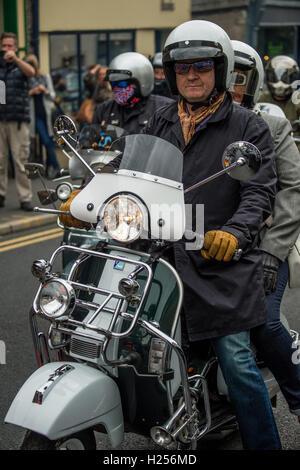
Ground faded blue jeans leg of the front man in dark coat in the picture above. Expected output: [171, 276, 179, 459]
[212, 331, 281, 450]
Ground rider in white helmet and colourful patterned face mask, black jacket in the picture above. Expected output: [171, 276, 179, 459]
[93, 52, 175, 134]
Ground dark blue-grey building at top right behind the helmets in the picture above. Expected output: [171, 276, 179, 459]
[192, 0, 300, 63]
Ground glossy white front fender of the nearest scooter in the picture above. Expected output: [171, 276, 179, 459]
[5, 362, 124, 447]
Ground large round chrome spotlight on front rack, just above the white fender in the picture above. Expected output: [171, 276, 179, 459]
[39, 279, 75, 319]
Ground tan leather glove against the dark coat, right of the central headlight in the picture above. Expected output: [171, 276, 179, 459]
[201, 230, 239, 262]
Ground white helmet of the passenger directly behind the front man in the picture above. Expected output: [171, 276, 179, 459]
[231, 41, 265, 108]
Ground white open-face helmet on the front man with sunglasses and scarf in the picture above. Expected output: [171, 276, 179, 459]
[163, 20, 234, 95]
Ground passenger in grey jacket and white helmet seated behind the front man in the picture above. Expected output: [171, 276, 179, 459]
[231, 41, 300, 419]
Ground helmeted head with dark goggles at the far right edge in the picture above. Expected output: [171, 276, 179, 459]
[266, 55, 299, 100]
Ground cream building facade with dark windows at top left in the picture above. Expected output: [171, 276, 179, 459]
[0, 0, 191, 113]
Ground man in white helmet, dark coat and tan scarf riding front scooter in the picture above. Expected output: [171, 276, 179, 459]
[144, 20, 281, 450]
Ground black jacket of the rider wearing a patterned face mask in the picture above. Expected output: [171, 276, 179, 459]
[93, 95, 173, 134]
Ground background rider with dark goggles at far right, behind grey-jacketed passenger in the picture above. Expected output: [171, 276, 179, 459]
[258, 55, 300, 150]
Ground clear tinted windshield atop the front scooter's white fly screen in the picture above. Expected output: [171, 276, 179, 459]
[111, 134, 183, 182]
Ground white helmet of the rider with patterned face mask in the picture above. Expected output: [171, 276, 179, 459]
[106, 52, 154, 97]
